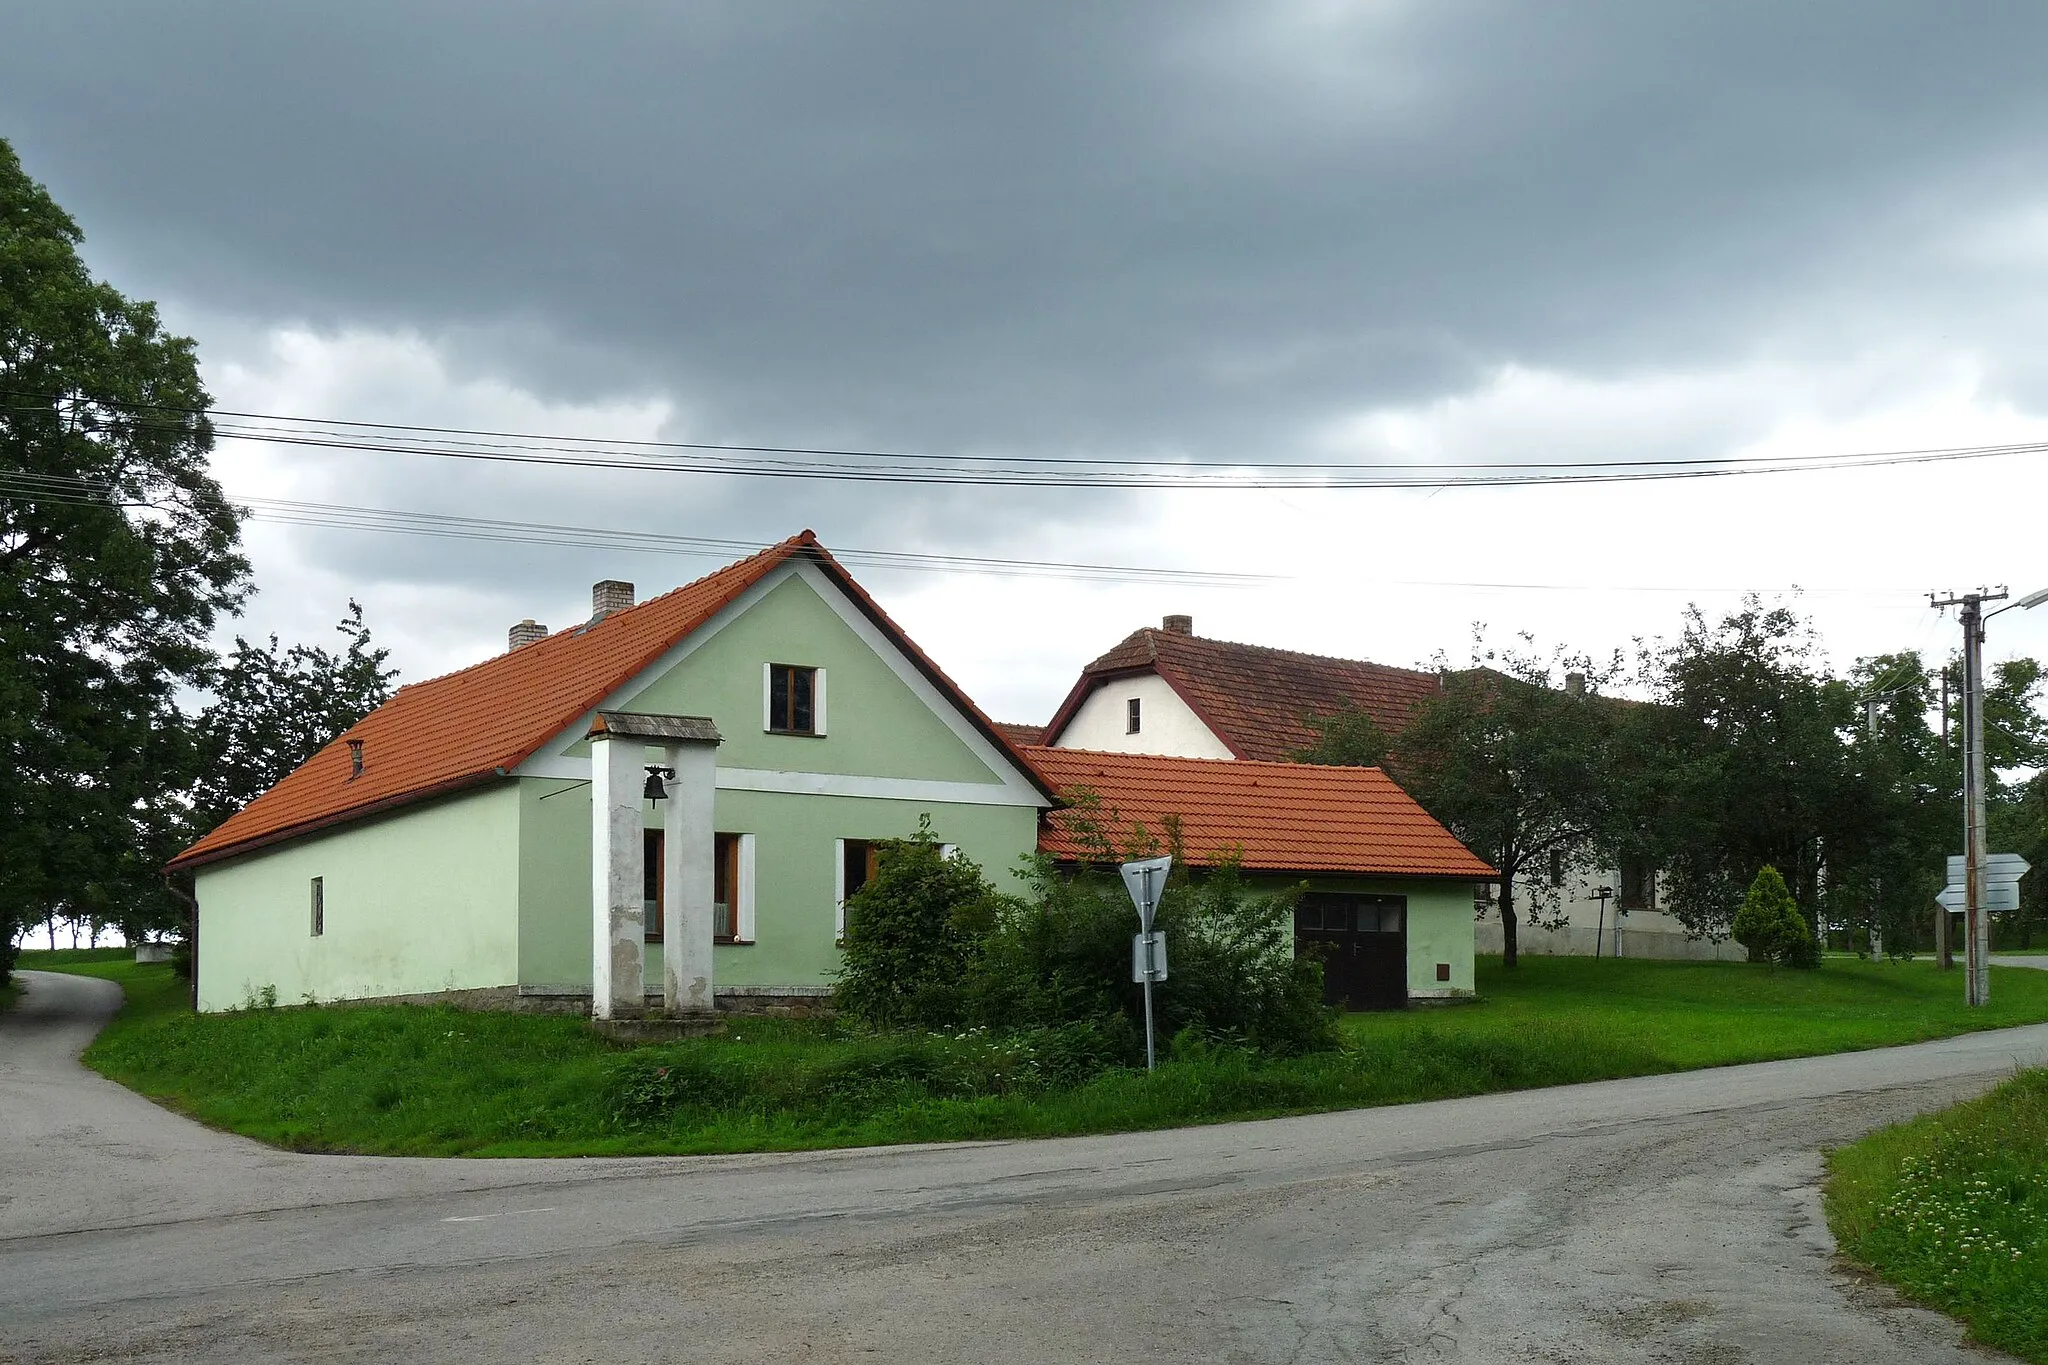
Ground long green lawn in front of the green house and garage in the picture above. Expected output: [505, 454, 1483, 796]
[23, 956, 2048, 1156]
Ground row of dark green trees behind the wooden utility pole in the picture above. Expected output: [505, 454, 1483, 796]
[1298, 596, 2048, 964]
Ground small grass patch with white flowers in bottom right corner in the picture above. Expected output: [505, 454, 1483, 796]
[1827, 1070, 2048, 1363]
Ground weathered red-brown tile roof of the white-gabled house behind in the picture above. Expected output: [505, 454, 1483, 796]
[1047, 628, 1440, 761]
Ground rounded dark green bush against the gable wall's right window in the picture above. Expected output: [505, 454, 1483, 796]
[836, 817, 999, 1029]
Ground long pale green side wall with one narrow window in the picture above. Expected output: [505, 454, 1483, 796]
[197, 782, 520, 1009]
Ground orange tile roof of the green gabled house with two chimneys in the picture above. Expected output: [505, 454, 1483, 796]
[170, 530, 1051, 868]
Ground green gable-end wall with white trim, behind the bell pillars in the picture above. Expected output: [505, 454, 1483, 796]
[518, 571, 1042, 990]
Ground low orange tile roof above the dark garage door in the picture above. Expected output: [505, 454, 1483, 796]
[1024, 749, 1495, 880]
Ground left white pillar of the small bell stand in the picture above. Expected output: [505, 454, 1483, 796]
[590, 720, 647, 1019]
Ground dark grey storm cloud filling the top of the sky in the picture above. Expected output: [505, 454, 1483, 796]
[16, 0, 2048, 454]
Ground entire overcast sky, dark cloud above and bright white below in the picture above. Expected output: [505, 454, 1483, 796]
[0, 0, 2048, 720]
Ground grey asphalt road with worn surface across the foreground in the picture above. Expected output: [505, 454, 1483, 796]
[0, 974, 2048, 1365]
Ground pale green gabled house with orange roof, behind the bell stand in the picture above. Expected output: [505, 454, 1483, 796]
[172, 532, 1055, 1017]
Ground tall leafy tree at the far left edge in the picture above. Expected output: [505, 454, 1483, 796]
[0, 141, 248, 982]
